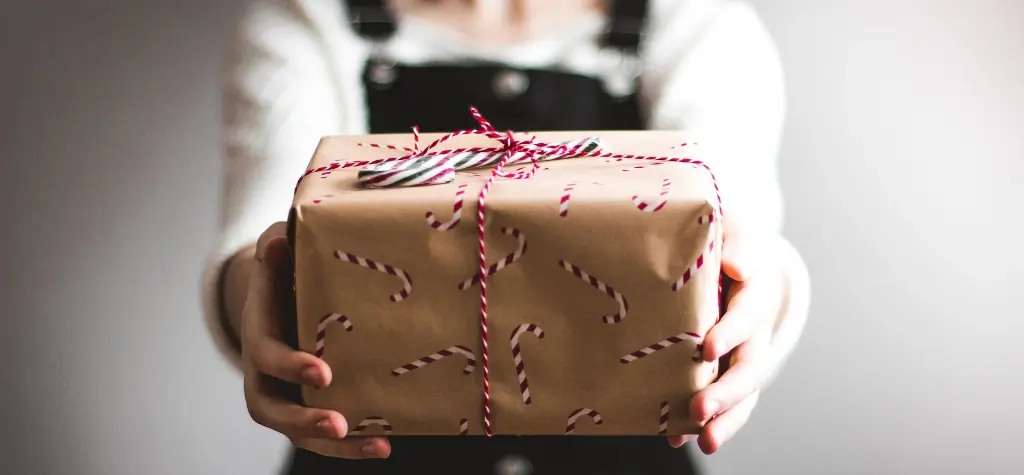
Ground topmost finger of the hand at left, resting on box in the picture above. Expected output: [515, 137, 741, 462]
[243, 246, 332, 387]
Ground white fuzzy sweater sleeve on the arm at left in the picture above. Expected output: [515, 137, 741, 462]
[202, 0, 341, 365]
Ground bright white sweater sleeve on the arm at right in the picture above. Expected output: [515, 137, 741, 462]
[641, 0, 810, 384]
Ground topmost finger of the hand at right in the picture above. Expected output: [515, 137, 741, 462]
[702, 272, 782, 361]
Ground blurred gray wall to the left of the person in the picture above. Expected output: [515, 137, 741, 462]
[0, 0, 284, 475]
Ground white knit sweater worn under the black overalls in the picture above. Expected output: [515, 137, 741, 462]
[203, 0, 809, 378]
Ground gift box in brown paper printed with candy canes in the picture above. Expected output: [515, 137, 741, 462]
[289, 114, 722, 435]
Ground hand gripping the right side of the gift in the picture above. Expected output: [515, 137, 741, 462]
[669, 220, 785, 455]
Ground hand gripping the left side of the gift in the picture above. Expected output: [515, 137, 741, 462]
[241, 223, 391, 459]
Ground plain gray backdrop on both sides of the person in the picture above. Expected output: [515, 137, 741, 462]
[0, 0, 1024, 475]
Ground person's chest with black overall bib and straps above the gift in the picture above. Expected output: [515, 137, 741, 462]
[356, 0, 646, 133]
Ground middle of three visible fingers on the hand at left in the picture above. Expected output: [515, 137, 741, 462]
[244, 366, 348, 439]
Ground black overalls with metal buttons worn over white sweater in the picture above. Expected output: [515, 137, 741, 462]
[288, 0, 695, 475]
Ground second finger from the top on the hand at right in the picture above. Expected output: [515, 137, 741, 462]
[690, 337, 768, 424]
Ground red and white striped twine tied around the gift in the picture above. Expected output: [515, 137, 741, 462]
[295, 107, 724, 436]
